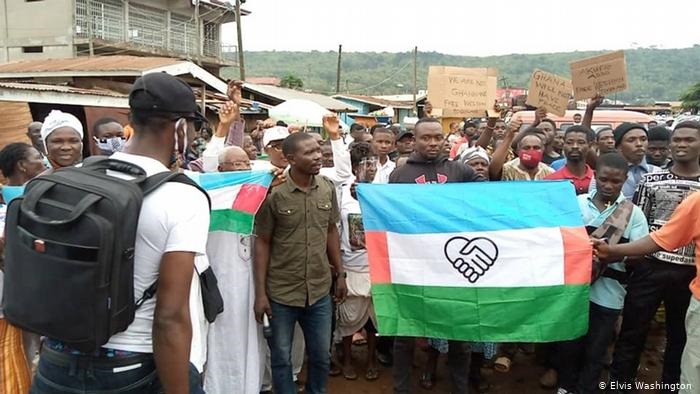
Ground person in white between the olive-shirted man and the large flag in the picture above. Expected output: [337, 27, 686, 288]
[336, 142, 379, 380]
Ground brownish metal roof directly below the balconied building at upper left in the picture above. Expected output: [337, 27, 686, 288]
[0, 56, 184, 75]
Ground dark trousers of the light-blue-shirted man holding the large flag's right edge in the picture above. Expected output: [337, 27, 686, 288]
[557, 302, 622, 394]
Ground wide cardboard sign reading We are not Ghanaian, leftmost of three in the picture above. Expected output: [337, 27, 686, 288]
[428, 66, 498, 118]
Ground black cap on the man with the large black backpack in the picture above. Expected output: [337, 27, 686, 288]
[129, 72, 206, 121]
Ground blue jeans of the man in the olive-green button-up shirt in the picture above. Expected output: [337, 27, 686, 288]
[268, 296, 333, 394]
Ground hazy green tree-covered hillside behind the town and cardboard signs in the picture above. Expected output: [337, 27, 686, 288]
[222, 45, 700, 103]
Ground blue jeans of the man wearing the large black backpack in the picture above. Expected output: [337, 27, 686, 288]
[29, 353, 204, 394]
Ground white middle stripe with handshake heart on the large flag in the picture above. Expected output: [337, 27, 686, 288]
[387, 227, 564, 287]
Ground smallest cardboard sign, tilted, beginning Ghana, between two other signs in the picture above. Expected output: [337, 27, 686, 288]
[525, 69, 571, 116]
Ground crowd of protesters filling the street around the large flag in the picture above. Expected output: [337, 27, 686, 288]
[0, 74, 700, 394]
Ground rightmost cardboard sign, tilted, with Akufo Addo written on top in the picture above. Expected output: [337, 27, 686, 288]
[569, 51, 627, 100]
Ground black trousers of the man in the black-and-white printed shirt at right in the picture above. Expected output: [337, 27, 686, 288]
[610, 259, 696, 387]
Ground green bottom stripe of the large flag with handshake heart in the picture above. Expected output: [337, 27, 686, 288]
[372, 284, 589, 342]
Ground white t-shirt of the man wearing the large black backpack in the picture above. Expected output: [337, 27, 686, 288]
[104, 152, 209, 353]
